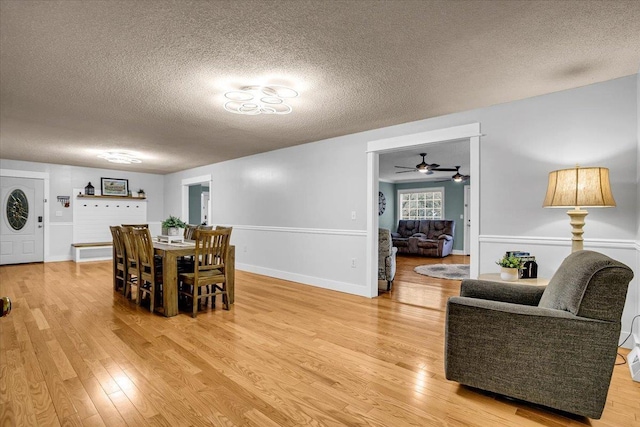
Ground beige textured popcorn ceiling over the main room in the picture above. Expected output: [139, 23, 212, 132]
[0, 0, 640, 173]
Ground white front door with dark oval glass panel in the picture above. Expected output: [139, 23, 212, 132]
[0, 177, 44, 265]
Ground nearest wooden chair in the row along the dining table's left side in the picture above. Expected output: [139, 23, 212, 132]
[133, 228, 162, 313]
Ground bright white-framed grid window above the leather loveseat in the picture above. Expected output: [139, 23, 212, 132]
[398, 187, 444, 219]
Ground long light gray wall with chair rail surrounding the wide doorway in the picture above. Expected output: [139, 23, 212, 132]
[165, 75, 638, 338]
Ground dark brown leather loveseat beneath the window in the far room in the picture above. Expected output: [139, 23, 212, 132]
[391, 219, 456, 258]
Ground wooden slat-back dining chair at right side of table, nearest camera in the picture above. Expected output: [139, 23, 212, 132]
[178, 230, 231, 317]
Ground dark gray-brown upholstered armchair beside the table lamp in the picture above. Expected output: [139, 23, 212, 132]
[445, 251, 633, 419]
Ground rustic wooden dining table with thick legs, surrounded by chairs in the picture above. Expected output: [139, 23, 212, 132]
[153, 240, 236, 317]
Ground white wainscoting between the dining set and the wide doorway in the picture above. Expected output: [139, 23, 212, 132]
[227, 224, 369, 296]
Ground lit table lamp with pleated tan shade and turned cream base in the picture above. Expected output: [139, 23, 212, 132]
[542, 166, 616, 252]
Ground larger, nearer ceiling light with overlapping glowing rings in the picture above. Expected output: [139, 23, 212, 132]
[224, 85, 298, 116]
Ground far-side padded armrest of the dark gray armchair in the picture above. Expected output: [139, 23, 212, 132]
[460, 279, 545, 306]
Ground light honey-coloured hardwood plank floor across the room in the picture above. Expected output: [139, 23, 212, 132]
[0, 257, 640, 427]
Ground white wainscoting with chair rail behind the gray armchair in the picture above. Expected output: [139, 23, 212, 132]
[479, 235, 640, 347]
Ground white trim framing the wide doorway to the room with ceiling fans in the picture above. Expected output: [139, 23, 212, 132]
[366, 123, 481, 298]
